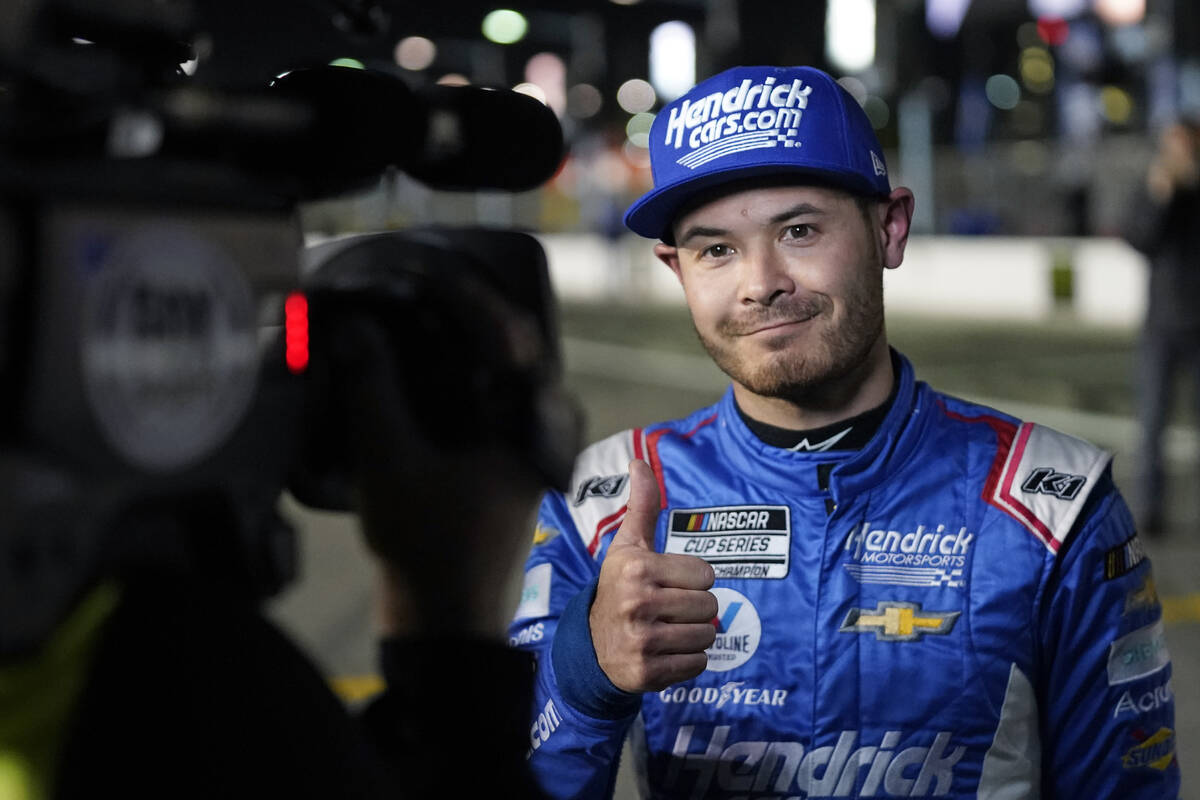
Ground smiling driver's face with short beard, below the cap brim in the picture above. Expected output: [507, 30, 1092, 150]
[655, 186, 911, 402]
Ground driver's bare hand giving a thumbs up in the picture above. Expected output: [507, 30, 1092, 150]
[588, 461, 718, 692]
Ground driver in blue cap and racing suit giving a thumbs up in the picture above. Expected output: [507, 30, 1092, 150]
[510, 67, 1180, 798]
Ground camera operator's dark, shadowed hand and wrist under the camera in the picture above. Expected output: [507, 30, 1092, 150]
[335, 317, 541, 638]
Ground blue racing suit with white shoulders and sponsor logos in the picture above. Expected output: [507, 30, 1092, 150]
[510, 357, 1180, 799]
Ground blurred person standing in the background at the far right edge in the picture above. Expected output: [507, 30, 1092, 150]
[1126, 120, 1200, 536]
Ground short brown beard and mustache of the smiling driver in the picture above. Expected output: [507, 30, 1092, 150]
[696, 270, 883, 403]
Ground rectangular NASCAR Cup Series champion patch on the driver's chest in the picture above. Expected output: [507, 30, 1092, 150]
[664, 506, 792, 578]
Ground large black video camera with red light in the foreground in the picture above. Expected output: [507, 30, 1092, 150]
[0, 0, 578, 657]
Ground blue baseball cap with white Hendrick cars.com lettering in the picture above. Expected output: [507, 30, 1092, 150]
[625, 67, 892, 240]
